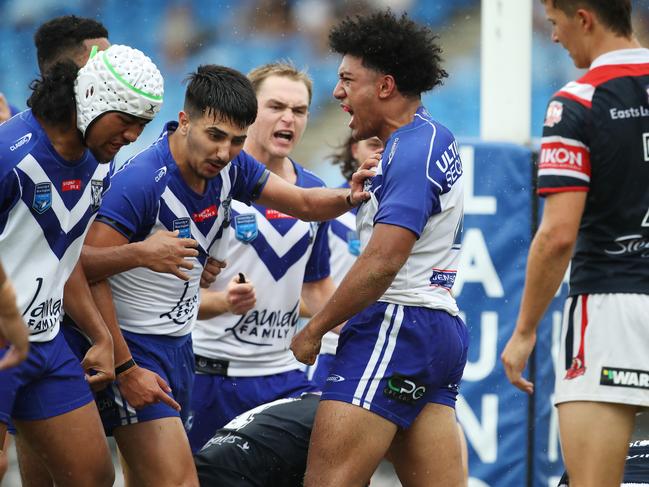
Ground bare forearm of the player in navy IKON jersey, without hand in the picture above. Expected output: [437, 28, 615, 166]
[516, 231, 574, 335]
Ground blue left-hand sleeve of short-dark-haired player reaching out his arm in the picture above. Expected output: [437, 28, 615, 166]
[97, 161, 160, 241]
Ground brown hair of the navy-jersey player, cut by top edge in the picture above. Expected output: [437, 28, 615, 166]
[541, 0, 633, 38]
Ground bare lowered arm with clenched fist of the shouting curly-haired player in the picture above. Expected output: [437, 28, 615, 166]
[291, 223, 416, 364]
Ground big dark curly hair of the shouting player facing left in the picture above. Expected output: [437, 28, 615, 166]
[329, 9, 448, 96]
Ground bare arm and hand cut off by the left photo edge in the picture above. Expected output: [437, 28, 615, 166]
[0, 265, 29, 370]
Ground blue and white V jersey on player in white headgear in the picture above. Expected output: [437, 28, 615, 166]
[0, 110, 111, 342]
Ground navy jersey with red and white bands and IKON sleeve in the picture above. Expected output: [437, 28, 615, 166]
[539, 49, 649, 295]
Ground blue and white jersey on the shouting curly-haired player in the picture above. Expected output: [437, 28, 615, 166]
[357, 107, 464, 315]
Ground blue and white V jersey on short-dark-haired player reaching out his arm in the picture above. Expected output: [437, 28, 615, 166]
[98, 122, 268, 336]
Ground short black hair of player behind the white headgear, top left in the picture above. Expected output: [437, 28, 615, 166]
[34, 15, 108, 72]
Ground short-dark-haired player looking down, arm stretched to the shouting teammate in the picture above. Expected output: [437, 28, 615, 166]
[84, 65, 366, 486]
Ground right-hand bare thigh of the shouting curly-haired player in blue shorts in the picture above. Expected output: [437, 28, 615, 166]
[390, 403, 464, 487]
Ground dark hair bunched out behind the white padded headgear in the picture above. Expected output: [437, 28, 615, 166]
[27, 60, 79, 127]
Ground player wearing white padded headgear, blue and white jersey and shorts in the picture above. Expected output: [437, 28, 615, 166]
[0, 46, 162, 486]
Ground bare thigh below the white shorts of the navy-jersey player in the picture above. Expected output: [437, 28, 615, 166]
[558, 401, 636, 487]
